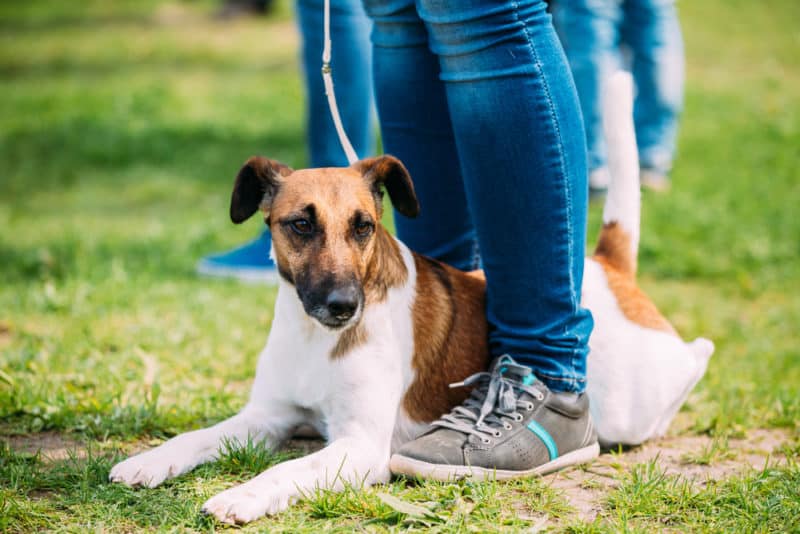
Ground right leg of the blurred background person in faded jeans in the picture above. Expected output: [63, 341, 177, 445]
[623, 0, 684, 179]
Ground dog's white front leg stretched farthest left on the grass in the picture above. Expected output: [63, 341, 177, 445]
[108, 403, 301, 488]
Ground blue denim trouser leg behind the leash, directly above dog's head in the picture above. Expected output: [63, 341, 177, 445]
[297, 0, 375, 167]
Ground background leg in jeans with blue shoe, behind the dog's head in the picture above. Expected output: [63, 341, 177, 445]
[197, 0, 375, 282]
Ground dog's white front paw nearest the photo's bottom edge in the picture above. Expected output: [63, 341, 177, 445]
[203, 483, 294, 524]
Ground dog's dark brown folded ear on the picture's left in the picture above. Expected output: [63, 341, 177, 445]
[231, 156, 292, 224]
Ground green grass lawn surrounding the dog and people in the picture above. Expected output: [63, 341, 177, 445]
[0, 0, 800, 532]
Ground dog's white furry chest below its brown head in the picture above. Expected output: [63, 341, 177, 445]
[251, 246, 422, 435]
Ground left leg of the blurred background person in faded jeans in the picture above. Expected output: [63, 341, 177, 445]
[553, 0, 622, 193]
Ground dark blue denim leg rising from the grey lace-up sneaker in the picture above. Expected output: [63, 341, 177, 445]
[417, 0, 592, 392]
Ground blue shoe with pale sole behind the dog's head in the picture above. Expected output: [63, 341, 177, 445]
[197, 230, 278, 284]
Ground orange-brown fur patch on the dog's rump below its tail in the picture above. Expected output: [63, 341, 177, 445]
[594, 255, 678, 336]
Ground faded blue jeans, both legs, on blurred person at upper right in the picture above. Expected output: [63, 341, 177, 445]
[553, 0, 684, 174]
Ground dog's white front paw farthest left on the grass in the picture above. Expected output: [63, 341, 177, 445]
[108, 448, 192, 488]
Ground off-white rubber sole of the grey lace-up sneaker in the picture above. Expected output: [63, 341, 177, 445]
[389, 443, 600, 482]
